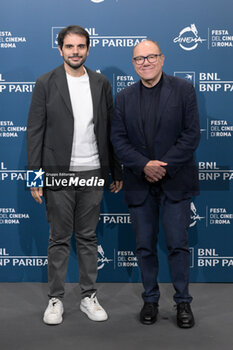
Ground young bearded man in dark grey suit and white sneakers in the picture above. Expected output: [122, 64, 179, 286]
[27, 26, 122, 324]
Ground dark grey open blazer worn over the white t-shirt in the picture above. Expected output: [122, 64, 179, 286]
[27, 65, 121, 183]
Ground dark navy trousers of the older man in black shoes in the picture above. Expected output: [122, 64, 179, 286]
[129, 187, 192, 303]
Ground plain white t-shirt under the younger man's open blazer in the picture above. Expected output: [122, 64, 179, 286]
[66, 70, 100, 171]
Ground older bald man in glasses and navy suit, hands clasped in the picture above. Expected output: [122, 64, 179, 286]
[111, 40, 200, 328]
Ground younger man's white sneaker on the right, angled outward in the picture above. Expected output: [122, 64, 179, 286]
[80, 293, 108, 321]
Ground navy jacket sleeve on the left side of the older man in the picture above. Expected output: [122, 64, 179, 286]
[111, 94, 150, 176]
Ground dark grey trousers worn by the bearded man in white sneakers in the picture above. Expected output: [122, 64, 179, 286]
[45, 170, 103, 298]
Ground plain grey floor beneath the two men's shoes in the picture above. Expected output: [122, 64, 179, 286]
[0, 283, 233, 350]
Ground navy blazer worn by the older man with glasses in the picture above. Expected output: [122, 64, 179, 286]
[111, 73, 200, 205]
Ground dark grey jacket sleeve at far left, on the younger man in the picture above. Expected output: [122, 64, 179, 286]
[27, 80, 46, 169]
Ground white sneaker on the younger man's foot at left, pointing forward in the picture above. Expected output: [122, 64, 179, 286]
[43, 298, 64, 324]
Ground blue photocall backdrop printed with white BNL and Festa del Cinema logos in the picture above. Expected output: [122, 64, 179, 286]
[0, 0, 233, 282]
